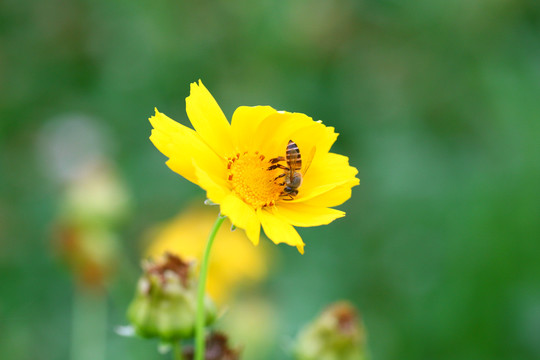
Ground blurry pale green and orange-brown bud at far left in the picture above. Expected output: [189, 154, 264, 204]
[52, 162, 129, 291]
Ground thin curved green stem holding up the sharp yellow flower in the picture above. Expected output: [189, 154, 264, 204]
[195, 214, 225, 360]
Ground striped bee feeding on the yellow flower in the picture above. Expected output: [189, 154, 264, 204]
[268, 140, 315, 200]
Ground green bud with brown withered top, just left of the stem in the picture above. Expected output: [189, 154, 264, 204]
[128, 253, 216, 341]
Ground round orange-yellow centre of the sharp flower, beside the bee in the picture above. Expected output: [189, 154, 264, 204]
[227, 152, 283, 209]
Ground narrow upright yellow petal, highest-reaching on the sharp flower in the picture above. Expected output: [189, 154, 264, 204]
[186, 80, 234, 157]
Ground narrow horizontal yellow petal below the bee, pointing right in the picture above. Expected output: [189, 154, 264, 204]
[273, 202, 345, 227]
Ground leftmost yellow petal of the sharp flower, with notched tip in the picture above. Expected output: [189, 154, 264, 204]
[149, 109, 226, 184]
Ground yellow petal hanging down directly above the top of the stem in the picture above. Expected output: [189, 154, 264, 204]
[221, 193, 261, 245]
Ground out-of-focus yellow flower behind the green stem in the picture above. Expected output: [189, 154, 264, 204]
[146, 208, 267, 302]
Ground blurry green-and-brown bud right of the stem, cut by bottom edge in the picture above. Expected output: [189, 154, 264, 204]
[294, 302, 366, 360]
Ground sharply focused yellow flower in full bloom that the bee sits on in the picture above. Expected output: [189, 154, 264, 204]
[150, 80, 360, 253]
